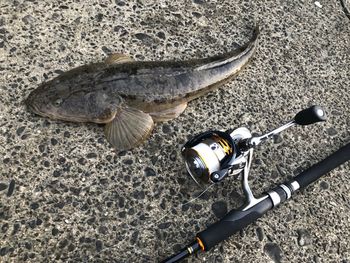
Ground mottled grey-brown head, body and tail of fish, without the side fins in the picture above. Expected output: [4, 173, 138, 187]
[26, 28, 258, 123]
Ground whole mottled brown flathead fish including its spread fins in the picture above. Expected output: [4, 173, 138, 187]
[25, 26, 259, 151]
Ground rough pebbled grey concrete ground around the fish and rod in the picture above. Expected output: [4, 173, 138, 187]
[0, 0, 350, 263]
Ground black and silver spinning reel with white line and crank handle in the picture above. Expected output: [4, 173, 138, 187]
[181, 106, 326, 209]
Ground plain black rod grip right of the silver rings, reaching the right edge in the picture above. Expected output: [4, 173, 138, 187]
[292, 143, 350, 188]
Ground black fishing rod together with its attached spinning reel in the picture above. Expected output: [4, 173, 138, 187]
[162, 106, 350, 263]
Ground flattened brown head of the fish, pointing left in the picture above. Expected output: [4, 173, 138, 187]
[25, 77, 123, 123]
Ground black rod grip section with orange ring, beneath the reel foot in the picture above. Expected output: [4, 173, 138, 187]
[197, 197, 273, 251]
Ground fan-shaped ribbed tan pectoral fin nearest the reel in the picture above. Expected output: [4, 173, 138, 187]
[105, 108, 154, 151]
